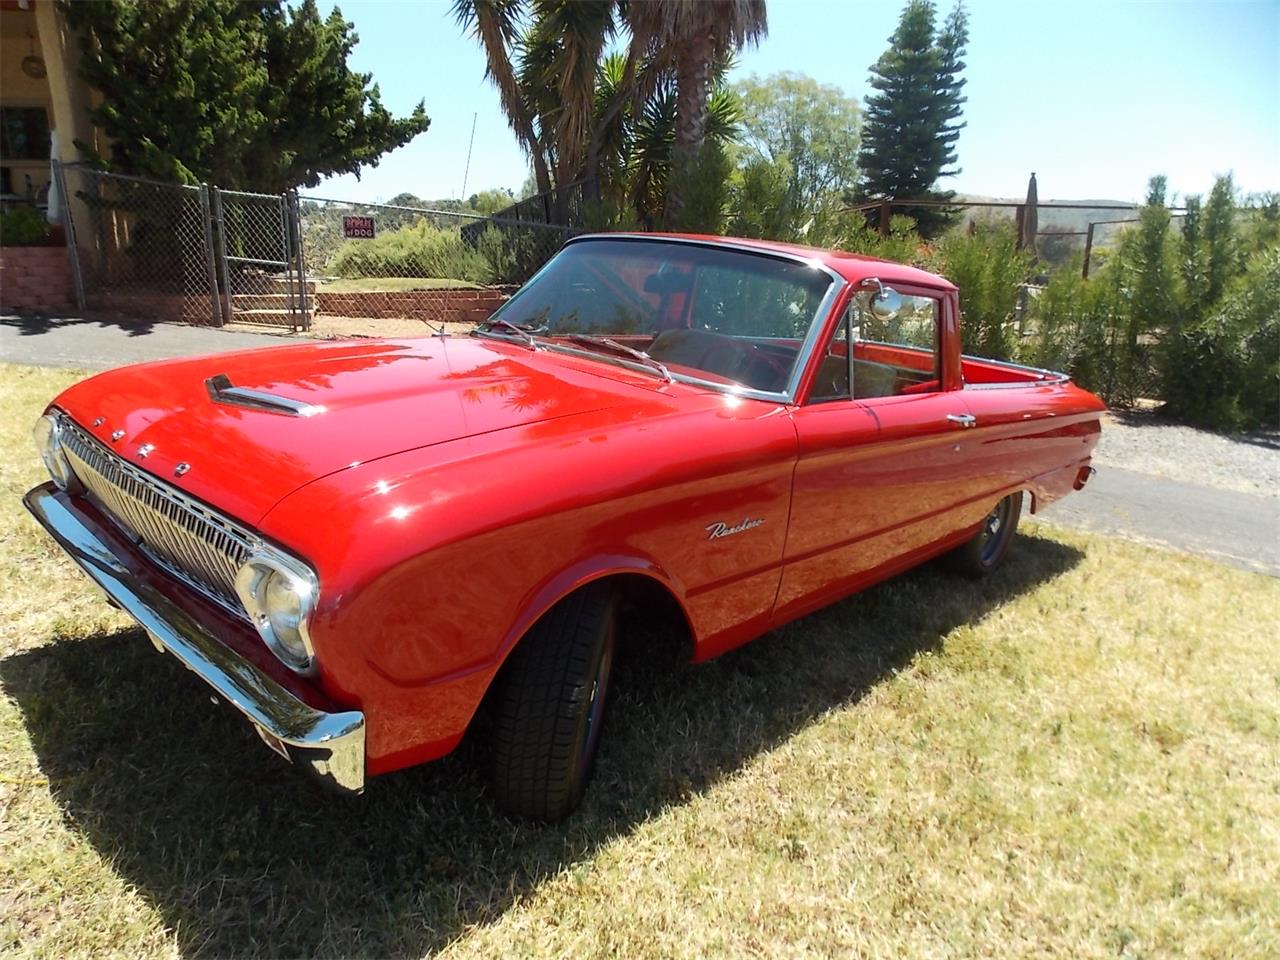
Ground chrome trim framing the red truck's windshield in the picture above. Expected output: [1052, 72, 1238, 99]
[471, 239, 849, 403]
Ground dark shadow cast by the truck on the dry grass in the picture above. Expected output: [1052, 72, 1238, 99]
[0, 534, 1083, 956]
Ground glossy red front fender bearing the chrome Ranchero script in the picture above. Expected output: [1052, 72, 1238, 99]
[262, 397, 795, 772]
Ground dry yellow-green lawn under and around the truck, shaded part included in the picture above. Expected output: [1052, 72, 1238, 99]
[0, 367, 1280, 957]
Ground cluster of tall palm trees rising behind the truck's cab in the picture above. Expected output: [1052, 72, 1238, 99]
[453, 0, 764, 223]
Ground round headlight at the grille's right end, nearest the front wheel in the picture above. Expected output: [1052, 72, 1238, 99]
[236, 545, 320, 673]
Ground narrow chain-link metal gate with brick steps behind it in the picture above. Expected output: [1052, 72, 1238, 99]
[210, 187, 315, 330]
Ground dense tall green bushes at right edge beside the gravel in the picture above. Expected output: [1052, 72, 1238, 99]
[1019, 177, 1280, 430]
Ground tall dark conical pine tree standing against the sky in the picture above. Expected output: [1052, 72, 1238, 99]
[855, 0, 969, 237]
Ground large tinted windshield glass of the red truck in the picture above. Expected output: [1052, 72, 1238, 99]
[489, 238, 833, 393]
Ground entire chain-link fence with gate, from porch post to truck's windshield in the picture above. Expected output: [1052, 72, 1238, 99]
[49, 165, 573, 335]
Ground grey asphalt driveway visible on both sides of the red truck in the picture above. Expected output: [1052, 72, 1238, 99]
[0, 315, 1280, 577]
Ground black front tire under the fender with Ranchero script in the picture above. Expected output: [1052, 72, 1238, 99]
[493, 585, 617, 822]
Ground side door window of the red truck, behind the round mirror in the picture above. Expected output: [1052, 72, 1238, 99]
[809, 293, 942, 403]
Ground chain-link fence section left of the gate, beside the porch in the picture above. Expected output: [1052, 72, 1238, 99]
[60, 165, 221, 324]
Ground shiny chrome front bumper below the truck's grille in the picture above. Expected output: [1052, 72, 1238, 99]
[23, 483, 365, 794]
